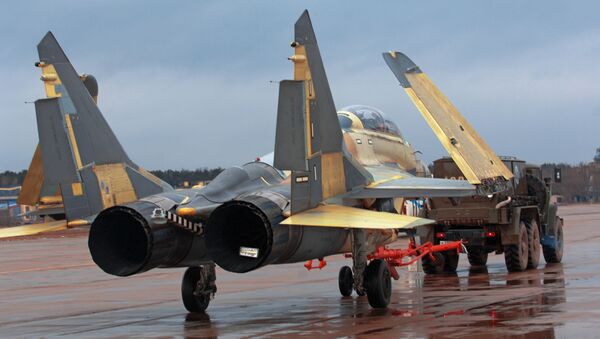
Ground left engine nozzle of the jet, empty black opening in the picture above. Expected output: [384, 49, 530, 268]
[88, 201, 206, 276]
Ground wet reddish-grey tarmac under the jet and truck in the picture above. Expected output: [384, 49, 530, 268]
[0, 205, 600, 338]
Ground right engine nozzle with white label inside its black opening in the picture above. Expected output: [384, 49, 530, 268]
[205, 196, 288, 273]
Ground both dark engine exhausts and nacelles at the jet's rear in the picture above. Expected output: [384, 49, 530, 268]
[89, 195, 348, 276]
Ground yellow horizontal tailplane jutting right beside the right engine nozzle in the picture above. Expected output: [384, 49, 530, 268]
[281, 205, 435, 229]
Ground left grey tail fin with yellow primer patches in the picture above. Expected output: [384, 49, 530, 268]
[21, 32, 172, 220]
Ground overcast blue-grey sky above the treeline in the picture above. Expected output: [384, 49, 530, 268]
[0, 0, 600, 171]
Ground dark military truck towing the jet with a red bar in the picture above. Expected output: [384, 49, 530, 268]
[419, 157, 564, 274]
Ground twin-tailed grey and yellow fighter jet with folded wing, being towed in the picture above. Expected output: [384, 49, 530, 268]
[22, 11, 511, 312]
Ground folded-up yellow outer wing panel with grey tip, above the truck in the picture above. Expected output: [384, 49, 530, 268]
[383, 52, 513, 184]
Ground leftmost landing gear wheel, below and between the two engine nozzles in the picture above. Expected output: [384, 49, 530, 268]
[181, 263, 217, 313]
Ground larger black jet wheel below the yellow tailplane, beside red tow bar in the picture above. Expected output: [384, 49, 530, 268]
[365, 259, 392, 308]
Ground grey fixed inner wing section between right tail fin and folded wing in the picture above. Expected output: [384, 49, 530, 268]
[344, 177, 476, 199]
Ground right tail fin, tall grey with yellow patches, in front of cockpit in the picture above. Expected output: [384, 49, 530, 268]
[274, 11, 372, 213]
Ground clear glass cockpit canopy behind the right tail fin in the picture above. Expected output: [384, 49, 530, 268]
[338, 105, 404, 139]
